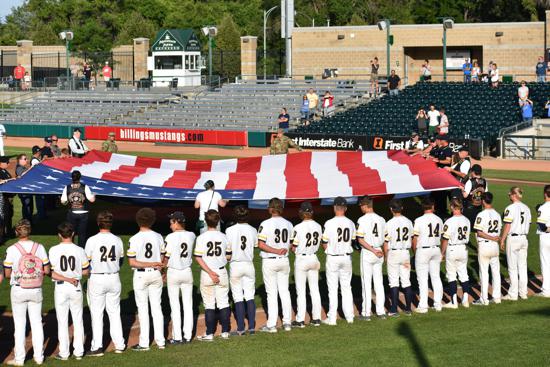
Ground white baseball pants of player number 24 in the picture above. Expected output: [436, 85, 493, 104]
[87, 273, 125, 350]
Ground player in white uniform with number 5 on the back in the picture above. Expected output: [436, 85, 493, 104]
[500, 186, 531, 301]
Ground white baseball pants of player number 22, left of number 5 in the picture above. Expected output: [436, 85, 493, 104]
[477, 239, 500, 303]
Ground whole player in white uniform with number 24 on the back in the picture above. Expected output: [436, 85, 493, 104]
[84, 211, 126, 357]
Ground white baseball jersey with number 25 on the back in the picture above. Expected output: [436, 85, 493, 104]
[194, 231, 231, 271]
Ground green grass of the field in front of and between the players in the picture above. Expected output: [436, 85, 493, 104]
[0, 147, 550, 366]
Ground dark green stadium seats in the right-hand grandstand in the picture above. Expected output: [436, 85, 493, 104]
[297, 82, 550, 143]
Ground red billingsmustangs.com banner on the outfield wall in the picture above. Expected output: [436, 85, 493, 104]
[85, 126, 248, 146]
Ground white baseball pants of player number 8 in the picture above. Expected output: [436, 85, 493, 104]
[133, 268, 165, 348]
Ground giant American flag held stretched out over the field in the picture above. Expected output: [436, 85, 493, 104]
[0, 151, 460, 200]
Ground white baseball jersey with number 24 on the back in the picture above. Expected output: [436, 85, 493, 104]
[84, 232, 124, 274]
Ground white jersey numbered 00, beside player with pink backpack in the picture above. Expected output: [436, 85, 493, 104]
[49, 243, 90, 279]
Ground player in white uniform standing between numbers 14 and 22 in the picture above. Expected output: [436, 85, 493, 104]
[441, 198, 470, 309]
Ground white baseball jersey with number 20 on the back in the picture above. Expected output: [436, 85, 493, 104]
[323, 216, 356, 255]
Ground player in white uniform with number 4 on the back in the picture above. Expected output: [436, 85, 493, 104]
[357, 196, 386, 321]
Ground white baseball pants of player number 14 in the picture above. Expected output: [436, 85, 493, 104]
[415, 247, 443, 308]
